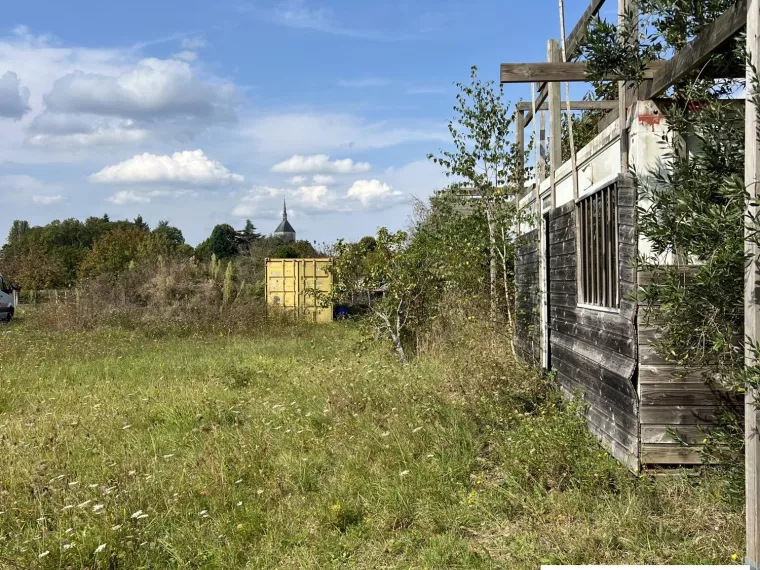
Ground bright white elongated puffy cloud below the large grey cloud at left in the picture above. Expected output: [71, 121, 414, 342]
[89, 150, 244, 186]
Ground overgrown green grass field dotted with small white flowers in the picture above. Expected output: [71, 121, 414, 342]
[0, 322, 744, 569]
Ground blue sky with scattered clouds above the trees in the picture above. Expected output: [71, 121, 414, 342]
[0, 0, 614, 245]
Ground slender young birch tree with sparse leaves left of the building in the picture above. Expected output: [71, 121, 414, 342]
[428, 66, 522, 321]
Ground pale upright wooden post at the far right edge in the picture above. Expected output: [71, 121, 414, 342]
[744, 0, 760, 560]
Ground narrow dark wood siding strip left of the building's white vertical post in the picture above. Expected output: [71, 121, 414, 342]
[515, 229, 543, 367]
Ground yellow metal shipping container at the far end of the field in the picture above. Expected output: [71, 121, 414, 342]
[266, 257, 333, 323]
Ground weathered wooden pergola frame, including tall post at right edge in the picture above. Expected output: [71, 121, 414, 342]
[500, 0, 760, 569]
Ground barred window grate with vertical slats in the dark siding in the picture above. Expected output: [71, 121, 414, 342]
[578, 183, 620, 308]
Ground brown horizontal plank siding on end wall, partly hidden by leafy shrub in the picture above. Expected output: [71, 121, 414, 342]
[638, 271, 744, 466]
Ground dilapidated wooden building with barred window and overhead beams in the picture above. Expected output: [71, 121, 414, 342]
[501, 0, 747, 471]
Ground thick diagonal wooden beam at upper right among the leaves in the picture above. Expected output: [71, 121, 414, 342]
[648, 0, 748, 98]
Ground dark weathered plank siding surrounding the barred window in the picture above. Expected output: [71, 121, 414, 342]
[548, 176, 639, 470]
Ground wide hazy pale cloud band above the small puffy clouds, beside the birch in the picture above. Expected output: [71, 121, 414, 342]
[241, 112, 451, 154]
